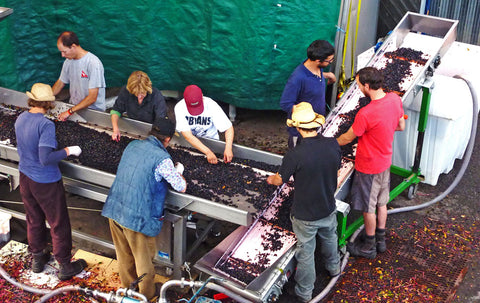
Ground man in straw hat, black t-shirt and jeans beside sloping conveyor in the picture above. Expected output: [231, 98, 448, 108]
[267, 102, 341, 302]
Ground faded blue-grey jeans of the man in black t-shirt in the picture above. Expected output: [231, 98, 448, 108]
[290, 211, 340, 301]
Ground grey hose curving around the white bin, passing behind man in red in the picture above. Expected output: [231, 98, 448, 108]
[310, 75, 478, 303]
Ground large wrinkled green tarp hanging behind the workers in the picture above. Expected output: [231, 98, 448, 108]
[0, 0, 341, 109]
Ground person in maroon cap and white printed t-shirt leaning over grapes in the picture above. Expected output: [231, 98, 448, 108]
[175, 85, 234, 164]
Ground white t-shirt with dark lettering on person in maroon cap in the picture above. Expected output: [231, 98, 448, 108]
[174, 96, 232, 140]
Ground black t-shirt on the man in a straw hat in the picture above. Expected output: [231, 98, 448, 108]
[279, 134, 342, 221]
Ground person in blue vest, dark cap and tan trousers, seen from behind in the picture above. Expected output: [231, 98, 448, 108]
[102, 118, 187, 300]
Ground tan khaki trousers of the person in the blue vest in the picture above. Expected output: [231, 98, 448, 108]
[108, 219, 156, 300]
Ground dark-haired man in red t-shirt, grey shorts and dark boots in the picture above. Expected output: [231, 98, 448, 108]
[337, 67, 405, 259]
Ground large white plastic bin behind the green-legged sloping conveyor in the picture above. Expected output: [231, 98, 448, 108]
[393, 42, 480, 185]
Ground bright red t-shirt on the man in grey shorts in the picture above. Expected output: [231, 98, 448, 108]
[352, 93, 403, 174]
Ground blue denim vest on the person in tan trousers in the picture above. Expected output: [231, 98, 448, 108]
[102, 136, 170, 237]
